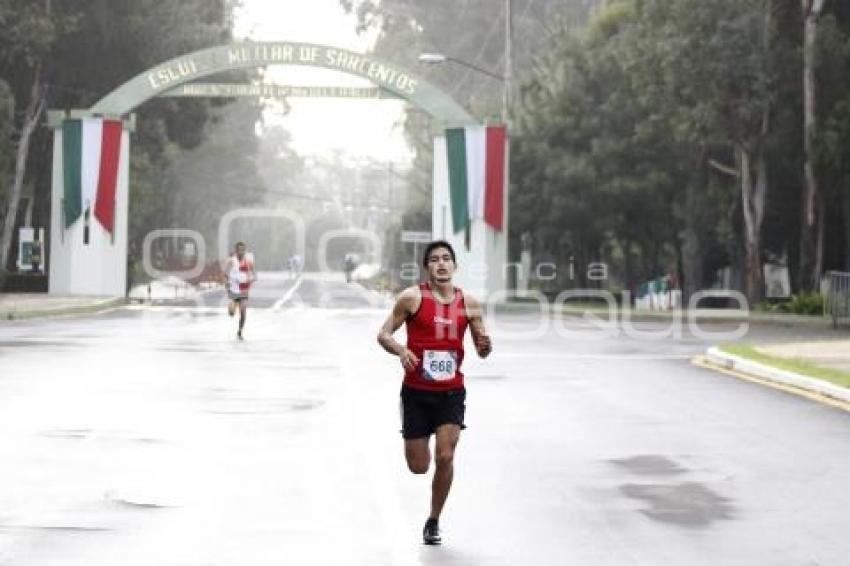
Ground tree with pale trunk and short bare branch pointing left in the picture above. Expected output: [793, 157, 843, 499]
[646, 0, 778, 302]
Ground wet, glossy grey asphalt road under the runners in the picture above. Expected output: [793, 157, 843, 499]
[0, 279, 850, 566]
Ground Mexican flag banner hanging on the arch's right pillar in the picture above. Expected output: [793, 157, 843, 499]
[446, 126, 507, 232]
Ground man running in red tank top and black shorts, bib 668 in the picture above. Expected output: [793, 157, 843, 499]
[378, 240, 492, 544]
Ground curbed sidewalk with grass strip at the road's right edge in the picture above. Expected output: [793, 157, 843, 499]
[697, 340, 850, 410]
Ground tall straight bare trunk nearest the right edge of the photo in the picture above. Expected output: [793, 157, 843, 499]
[798, 0, 825, 291]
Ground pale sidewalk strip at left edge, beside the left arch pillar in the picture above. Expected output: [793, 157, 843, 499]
[0, 293, 126, 322]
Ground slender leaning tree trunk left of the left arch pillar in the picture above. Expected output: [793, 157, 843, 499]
[0, 65, 45, 271]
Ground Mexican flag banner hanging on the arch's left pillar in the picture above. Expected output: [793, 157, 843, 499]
[62, 118, 122, 232]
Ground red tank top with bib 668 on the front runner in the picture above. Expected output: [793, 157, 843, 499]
[404, 283, 469, 391]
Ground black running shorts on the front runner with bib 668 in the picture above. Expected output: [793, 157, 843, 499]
[401, 385, 466, 440]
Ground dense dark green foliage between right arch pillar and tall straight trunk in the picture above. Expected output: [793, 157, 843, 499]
[504, 0, 836, 302]
